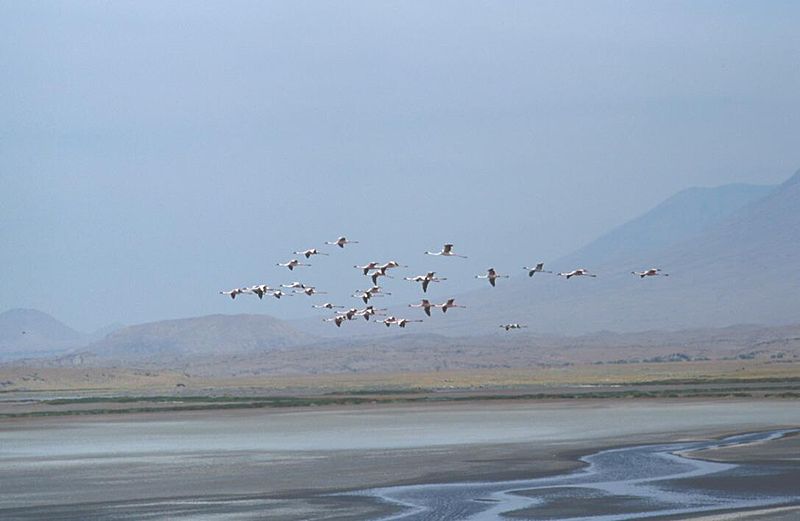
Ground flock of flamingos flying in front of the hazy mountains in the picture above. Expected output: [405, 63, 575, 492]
[219, 236, 669, 331]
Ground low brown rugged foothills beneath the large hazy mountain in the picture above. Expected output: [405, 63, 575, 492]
[108, 324, 800, 377]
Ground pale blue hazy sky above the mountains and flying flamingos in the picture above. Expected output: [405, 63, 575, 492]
[0, 0, 800, 330]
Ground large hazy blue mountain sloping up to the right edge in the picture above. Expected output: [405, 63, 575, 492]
[420, 172, 800, 335]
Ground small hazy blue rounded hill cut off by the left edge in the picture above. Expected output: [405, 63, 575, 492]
[0, 309, 86, 360]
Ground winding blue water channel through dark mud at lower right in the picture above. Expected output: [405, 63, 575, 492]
[360, 431, 800, 521]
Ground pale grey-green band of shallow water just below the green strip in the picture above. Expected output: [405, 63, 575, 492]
[0, 400, 800, 456]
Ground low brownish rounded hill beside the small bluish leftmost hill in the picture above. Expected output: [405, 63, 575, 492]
[74, 315, 315, 365]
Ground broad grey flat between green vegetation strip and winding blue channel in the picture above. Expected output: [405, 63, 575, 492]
[0, 400, 800, 521]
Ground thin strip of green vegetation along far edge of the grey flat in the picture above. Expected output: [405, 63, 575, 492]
[0, 383, 800, 420]
